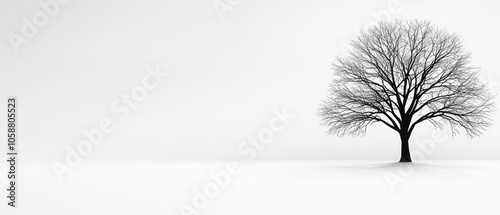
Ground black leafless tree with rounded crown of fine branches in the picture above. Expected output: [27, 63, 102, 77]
[318, 20, 495, 162]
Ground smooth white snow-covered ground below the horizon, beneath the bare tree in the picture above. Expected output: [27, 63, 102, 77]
[1, 161, 500, 215]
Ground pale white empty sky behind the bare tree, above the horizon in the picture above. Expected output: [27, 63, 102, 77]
[0, 0, 500, 160]
